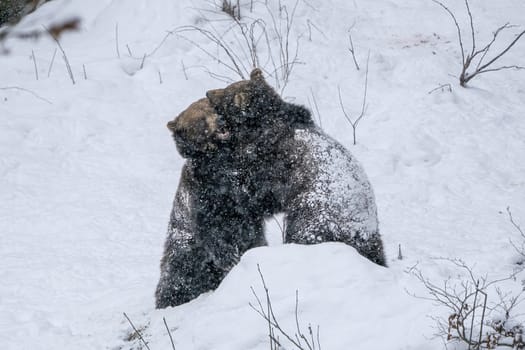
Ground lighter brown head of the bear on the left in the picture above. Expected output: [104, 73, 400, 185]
[167, 98, 231, 158]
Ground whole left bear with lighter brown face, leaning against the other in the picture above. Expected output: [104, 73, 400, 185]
[151, 98, 266, 308]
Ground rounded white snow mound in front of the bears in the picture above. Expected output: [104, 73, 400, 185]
[121, 243, 430, 350]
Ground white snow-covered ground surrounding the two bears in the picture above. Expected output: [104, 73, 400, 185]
[0, 0, 525, 350]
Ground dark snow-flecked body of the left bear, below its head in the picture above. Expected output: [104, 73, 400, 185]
[155, 159, 266, 308]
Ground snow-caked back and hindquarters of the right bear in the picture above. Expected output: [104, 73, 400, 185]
[285, 127, 386, 265]
